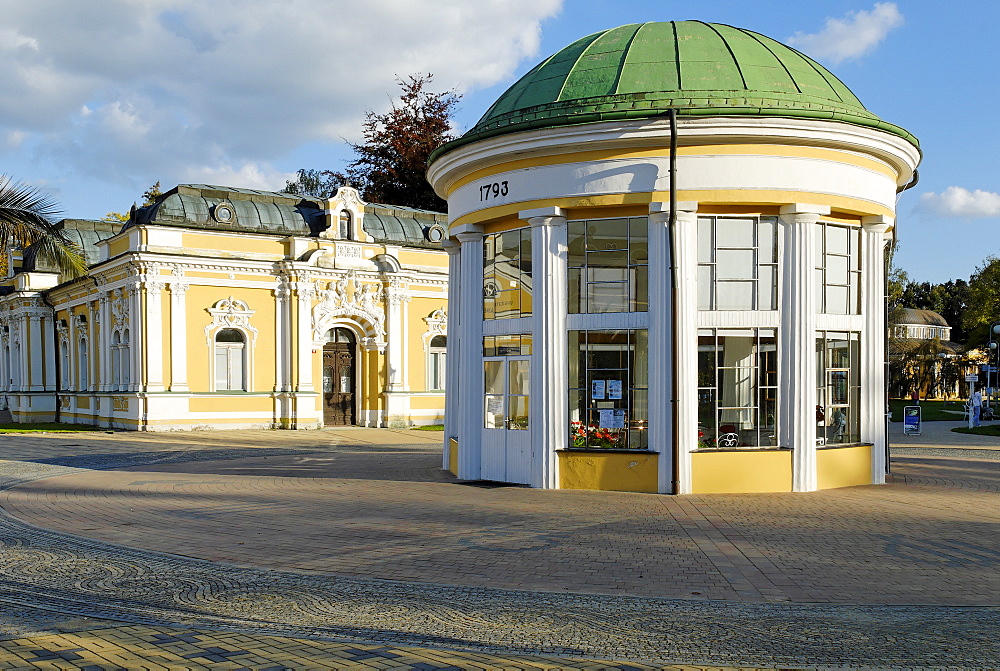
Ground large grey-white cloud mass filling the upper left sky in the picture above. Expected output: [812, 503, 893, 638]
[0, 0, 562, 194]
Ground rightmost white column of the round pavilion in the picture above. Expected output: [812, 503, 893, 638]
[859, 216, 893, 485]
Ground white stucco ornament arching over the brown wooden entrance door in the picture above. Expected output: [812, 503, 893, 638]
[312, 271, 385, 351]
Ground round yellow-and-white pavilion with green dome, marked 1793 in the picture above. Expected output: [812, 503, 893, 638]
[428, 21, 921, 494]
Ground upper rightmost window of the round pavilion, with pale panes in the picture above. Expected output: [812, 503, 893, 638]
[816, 222, 861, 315]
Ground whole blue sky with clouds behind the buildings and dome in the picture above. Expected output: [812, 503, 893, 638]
[0, 0, 1000, 282]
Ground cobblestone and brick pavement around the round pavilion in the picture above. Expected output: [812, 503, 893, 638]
[0, 430, 1000, 668]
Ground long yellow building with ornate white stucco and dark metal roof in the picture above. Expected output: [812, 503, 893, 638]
[0, 184, 448, 431]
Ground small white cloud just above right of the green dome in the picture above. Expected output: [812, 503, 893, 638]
[788, 2, 903, 65]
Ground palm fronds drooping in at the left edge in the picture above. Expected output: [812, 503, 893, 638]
[0, 175, 87, 277]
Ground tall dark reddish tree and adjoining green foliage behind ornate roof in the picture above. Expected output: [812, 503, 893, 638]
[285, 74, 461, 212]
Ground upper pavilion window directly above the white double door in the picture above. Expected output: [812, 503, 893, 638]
[483, 228, 531, 319]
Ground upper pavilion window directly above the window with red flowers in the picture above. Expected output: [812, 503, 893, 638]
[567, 217, 649, 314]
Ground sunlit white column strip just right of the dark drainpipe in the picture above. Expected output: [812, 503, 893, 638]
[668, 201, 698, 494]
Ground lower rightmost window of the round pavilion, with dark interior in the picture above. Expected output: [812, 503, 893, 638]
[816, 331, 861, 445]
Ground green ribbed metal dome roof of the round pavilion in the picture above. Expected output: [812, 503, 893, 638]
[431, 21, 919, 161]
